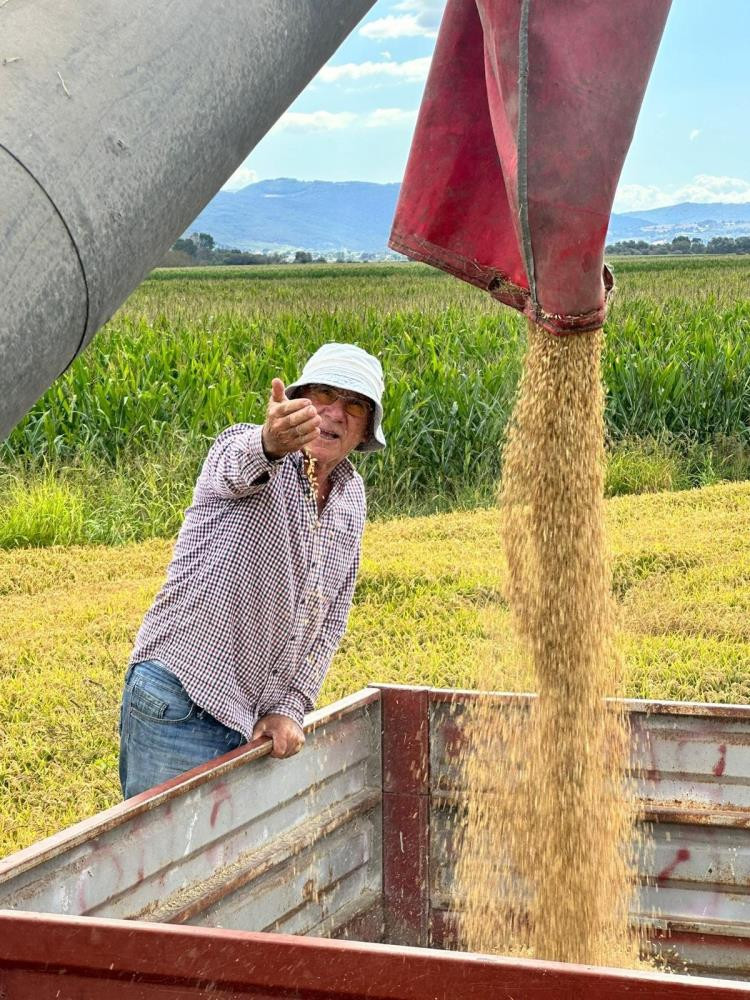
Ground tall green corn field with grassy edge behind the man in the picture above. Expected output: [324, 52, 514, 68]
[0, 257, 750, 546]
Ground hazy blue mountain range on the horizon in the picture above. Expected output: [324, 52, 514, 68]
[188, 177, 750, 255]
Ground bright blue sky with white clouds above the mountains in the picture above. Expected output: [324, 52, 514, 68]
[225, 0, 750, 212]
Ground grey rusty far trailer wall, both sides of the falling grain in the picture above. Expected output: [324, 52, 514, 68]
[429, 691, 750, 979]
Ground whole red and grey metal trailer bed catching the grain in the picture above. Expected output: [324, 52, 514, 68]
[0, 686, 750, 1000]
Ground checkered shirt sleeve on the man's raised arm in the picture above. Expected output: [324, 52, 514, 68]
[199, 424, 280, 500]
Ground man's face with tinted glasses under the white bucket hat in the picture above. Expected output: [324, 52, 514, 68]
[300, 385, 372, 469]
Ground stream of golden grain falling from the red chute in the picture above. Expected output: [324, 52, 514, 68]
[457, 324, 637, 965]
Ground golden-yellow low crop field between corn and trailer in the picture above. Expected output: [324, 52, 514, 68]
[0, 483, 750, 855]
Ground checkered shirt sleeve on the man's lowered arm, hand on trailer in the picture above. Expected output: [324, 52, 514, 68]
[268, 540, 361, 726]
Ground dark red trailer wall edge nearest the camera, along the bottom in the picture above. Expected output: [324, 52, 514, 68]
[5, 913, 750, 1000]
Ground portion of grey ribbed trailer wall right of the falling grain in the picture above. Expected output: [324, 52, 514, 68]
[631, 703, 750, 979]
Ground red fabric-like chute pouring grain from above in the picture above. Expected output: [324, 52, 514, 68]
[390, 0, 670, 334]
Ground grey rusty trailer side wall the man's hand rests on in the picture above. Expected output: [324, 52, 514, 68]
[0, 692, 382, 936]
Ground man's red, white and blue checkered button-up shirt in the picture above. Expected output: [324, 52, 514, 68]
[130, 424, 366, 739]
